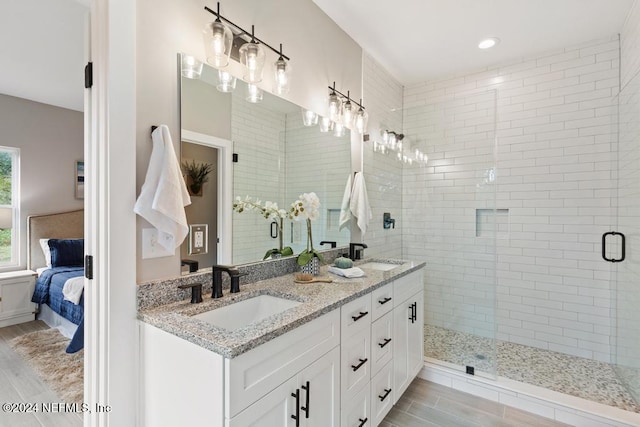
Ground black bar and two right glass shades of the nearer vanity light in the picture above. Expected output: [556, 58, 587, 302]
[204, 2, 291, 86]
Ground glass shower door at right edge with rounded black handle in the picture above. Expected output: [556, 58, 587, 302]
[607, 68, 640, 402]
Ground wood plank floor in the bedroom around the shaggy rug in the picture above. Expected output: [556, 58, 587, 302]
[0, 320, 82, 427]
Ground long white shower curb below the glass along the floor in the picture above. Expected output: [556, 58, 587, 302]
[418, 360, 640, 427]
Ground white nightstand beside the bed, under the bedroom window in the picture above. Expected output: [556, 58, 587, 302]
[0, 270, 36, 327]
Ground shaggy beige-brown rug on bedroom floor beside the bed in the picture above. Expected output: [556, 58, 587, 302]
[9, 329, 84, 403]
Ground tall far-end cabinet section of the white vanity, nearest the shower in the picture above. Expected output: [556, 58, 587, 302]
[393, 271, 424, 404]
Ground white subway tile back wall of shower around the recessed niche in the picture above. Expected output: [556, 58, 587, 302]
[404, 36, 620, 362]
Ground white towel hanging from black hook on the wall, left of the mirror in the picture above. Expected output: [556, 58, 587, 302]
[133, 125, 191, 252]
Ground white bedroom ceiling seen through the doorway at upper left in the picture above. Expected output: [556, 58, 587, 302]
[0, 0, 89, 111]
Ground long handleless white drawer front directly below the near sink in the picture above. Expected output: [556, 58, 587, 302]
[225, 310, 340, 419]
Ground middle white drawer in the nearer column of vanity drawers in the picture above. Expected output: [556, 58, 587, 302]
[340, 324, 371, 401]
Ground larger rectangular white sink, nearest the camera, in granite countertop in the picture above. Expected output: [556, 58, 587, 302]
[193, 295, 302, 331]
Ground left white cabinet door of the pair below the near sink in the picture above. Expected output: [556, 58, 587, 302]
[228, 377, 304, 427]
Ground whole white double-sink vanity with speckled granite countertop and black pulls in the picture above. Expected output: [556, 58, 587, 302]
[139, 262, 424, 427]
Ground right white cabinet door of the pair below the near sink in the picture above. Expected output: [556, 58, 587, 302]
[300, 347, 340, 427]
